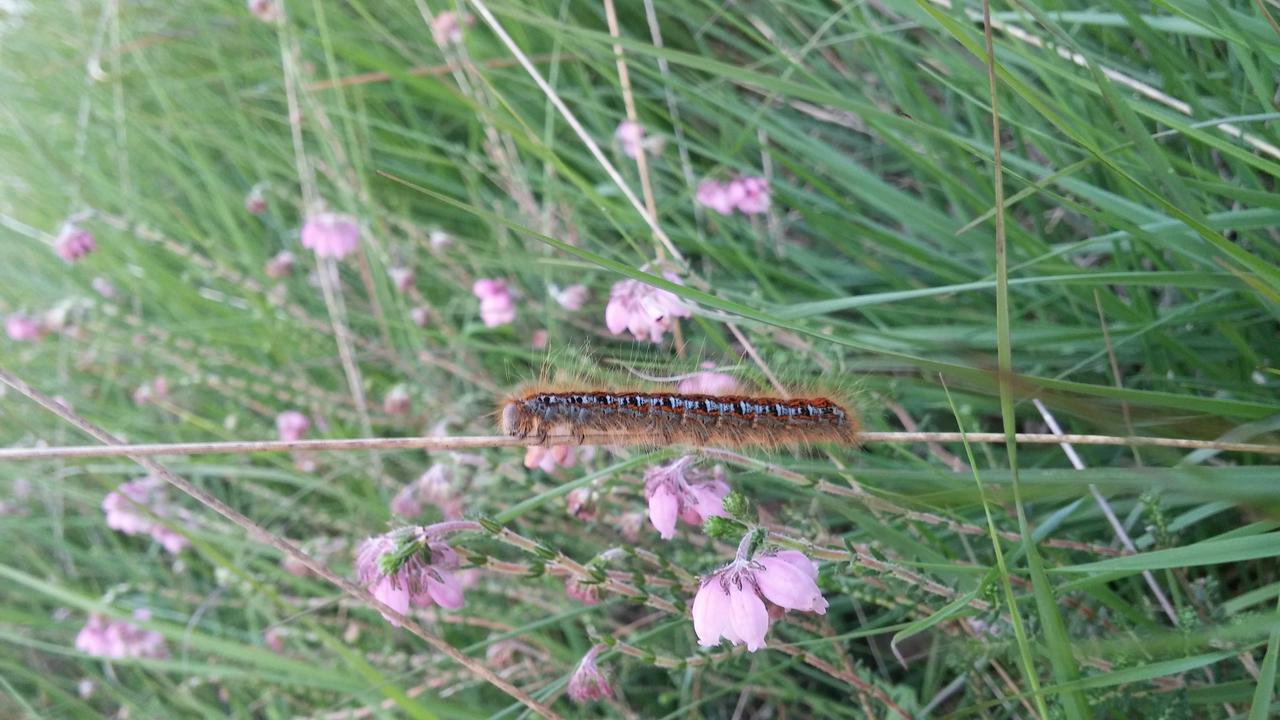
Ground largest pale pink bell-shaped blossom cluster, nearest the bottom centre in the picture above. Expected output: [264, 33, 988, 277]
[692, 541, 827, 652]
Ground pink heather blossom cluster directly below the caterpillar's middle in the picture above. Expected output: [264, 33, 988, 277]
[644, 455, 728, 539]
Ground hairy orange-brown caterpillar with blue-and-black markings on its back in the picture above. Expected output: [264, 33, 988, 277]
[500, 387, 859, 447]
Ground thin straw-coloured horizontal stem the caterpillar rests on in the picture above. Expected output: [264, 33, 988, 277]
[0, 432, 1280, 458]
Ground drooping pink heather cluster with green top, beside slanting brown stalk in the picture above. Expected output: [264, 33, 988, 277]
[356, 534, 463, 625]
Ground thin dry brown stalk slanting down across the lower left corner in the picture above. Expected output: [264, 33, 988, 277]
[0, 369, 559, 717]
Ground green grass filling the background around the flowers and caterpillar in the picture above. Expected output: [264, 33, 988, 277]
[0, 0, 1280, 719]
